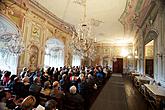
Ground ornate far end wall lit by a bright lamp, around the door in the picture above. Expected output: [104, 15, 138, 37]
[93, 43, 134, 73]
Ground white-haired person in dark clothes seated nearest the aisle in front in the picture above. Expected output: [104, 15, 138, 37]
[64, 85, 84, 110]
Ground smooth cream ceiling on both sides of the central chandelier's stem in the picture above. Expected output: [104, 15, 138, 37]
[36, 0, 131, 43]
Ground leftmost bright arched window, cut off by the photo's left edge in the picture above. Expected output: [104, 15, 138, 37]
[0, 15, 21, 74]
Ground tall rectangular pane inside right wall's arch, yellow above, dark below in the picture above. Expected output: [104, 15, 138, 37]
[145, 40, 154, 78]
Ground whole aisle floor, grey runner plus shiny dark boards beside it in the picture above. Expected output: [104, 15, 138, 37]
[90, 74, 150, 110]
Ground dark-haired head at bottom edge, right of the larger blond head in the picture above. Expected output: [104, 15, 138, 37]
[45, 99, 57, 110]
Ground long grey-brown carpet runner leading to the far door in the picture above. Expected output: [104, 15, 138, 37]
[90, 74, 128, 110]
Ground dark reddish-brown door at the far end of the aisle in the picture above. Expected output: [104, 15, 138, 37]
[113, 58, 123, 73]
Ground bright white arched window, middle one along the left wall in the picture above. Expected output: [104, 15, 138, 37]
[44, 38, 64, 68]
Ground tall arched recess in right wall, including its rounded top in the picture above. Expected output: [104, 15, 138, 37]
[144, 29, 161, 79]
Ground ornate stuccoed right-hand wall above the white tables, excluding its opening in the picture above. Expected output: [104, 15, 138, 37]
[120, 0, 165, 85]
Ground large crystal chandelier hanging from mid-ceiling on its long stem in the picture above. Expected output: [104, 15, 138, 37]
[70, 0, 96, 59]
